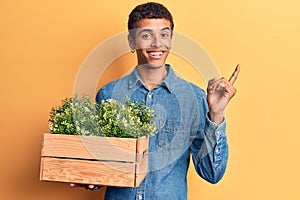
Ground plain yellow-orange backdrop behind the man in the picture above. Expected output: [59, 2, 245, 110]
[0, 0, 300, 200]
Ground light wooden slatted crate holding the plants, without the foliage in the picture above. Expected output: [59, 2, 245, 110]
[40, 133, 148, 187]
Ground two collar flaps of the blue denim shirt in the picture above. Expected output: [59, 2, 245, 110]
[128, 64, 178, 93]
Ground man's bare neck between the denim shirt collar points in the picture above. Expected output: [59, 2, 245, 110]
[137, 65, 168, 90]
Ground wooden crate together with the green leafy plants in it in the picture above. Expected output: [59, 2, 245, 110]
[40, 96, 157, 187]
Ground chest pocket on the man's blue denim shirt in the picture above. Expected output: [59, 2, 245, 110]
[158, 120, 188, 149]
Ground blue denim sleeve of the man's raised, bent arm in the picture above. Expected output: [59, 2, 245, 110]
[190, 96, 228, 183]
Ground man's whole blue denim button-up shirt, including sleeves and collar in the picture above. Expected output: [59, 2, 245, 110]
[96, 65, 228, 200]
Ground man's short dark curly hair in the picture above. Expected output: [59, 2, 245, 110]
[127, 2, 174, 36]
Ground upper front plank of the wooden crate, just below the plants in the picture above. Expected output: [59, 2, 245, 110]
[42, 133, 144, 162]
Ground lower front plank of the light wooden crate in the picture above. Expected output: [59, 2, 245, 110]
[40, 157, 135, 187]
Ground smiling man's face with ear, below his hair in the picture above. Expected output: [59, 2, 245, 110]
[129, 18, 172, 68]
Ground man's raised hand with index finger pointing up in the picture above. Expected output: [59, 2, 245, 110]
[207, 65, 240, 124]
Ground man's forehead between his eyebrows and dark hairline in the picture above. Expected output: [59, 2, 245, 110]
[137, 18, 171, 30]
